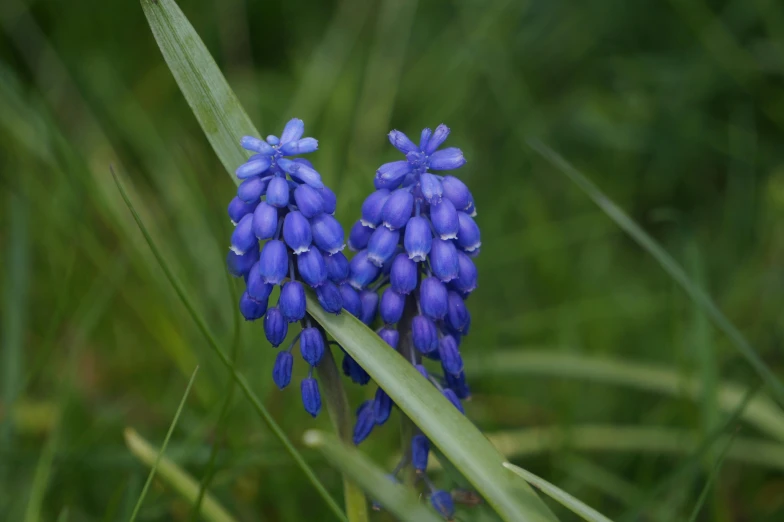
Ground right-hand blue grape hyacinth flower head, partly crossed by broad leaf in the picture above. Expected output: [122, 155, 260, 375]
[343, 125, 481, 518]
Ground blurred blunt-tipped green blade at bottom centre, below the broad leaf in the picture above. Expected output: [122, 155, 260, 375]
[304, 430, 443, 522]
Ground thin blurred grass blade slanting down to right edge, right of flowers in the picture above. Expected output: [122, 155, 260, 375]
[528, 140, 784, 406]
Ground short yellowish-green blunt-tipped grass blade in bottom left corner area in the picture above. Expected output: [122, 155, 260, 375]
[124, 428, 236, 522]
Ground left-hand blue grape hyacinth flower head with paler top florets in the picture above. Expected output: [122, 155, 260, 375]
[227, 119, 352, 417]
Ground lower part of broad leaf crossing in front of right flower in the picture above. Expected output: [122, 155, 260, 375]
[307, 292, 556, 522]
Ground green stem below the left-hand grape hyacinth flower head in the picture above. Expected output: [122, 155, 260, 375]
[318, 330, 368, 522]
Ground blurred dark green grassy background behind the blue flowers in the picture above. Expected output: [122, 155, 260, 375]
[0, 0, 784, 522]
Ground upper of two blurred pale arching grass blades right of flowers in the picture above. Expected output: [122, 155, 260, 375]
[465, 350, 784, 442]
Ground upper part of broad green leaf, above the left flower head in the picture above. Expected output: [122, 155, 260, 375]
[141, 0, 254, 184]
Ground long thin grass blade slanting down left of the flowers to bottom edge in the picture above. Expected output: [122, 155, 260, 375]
[112, 170, 348, 522]
